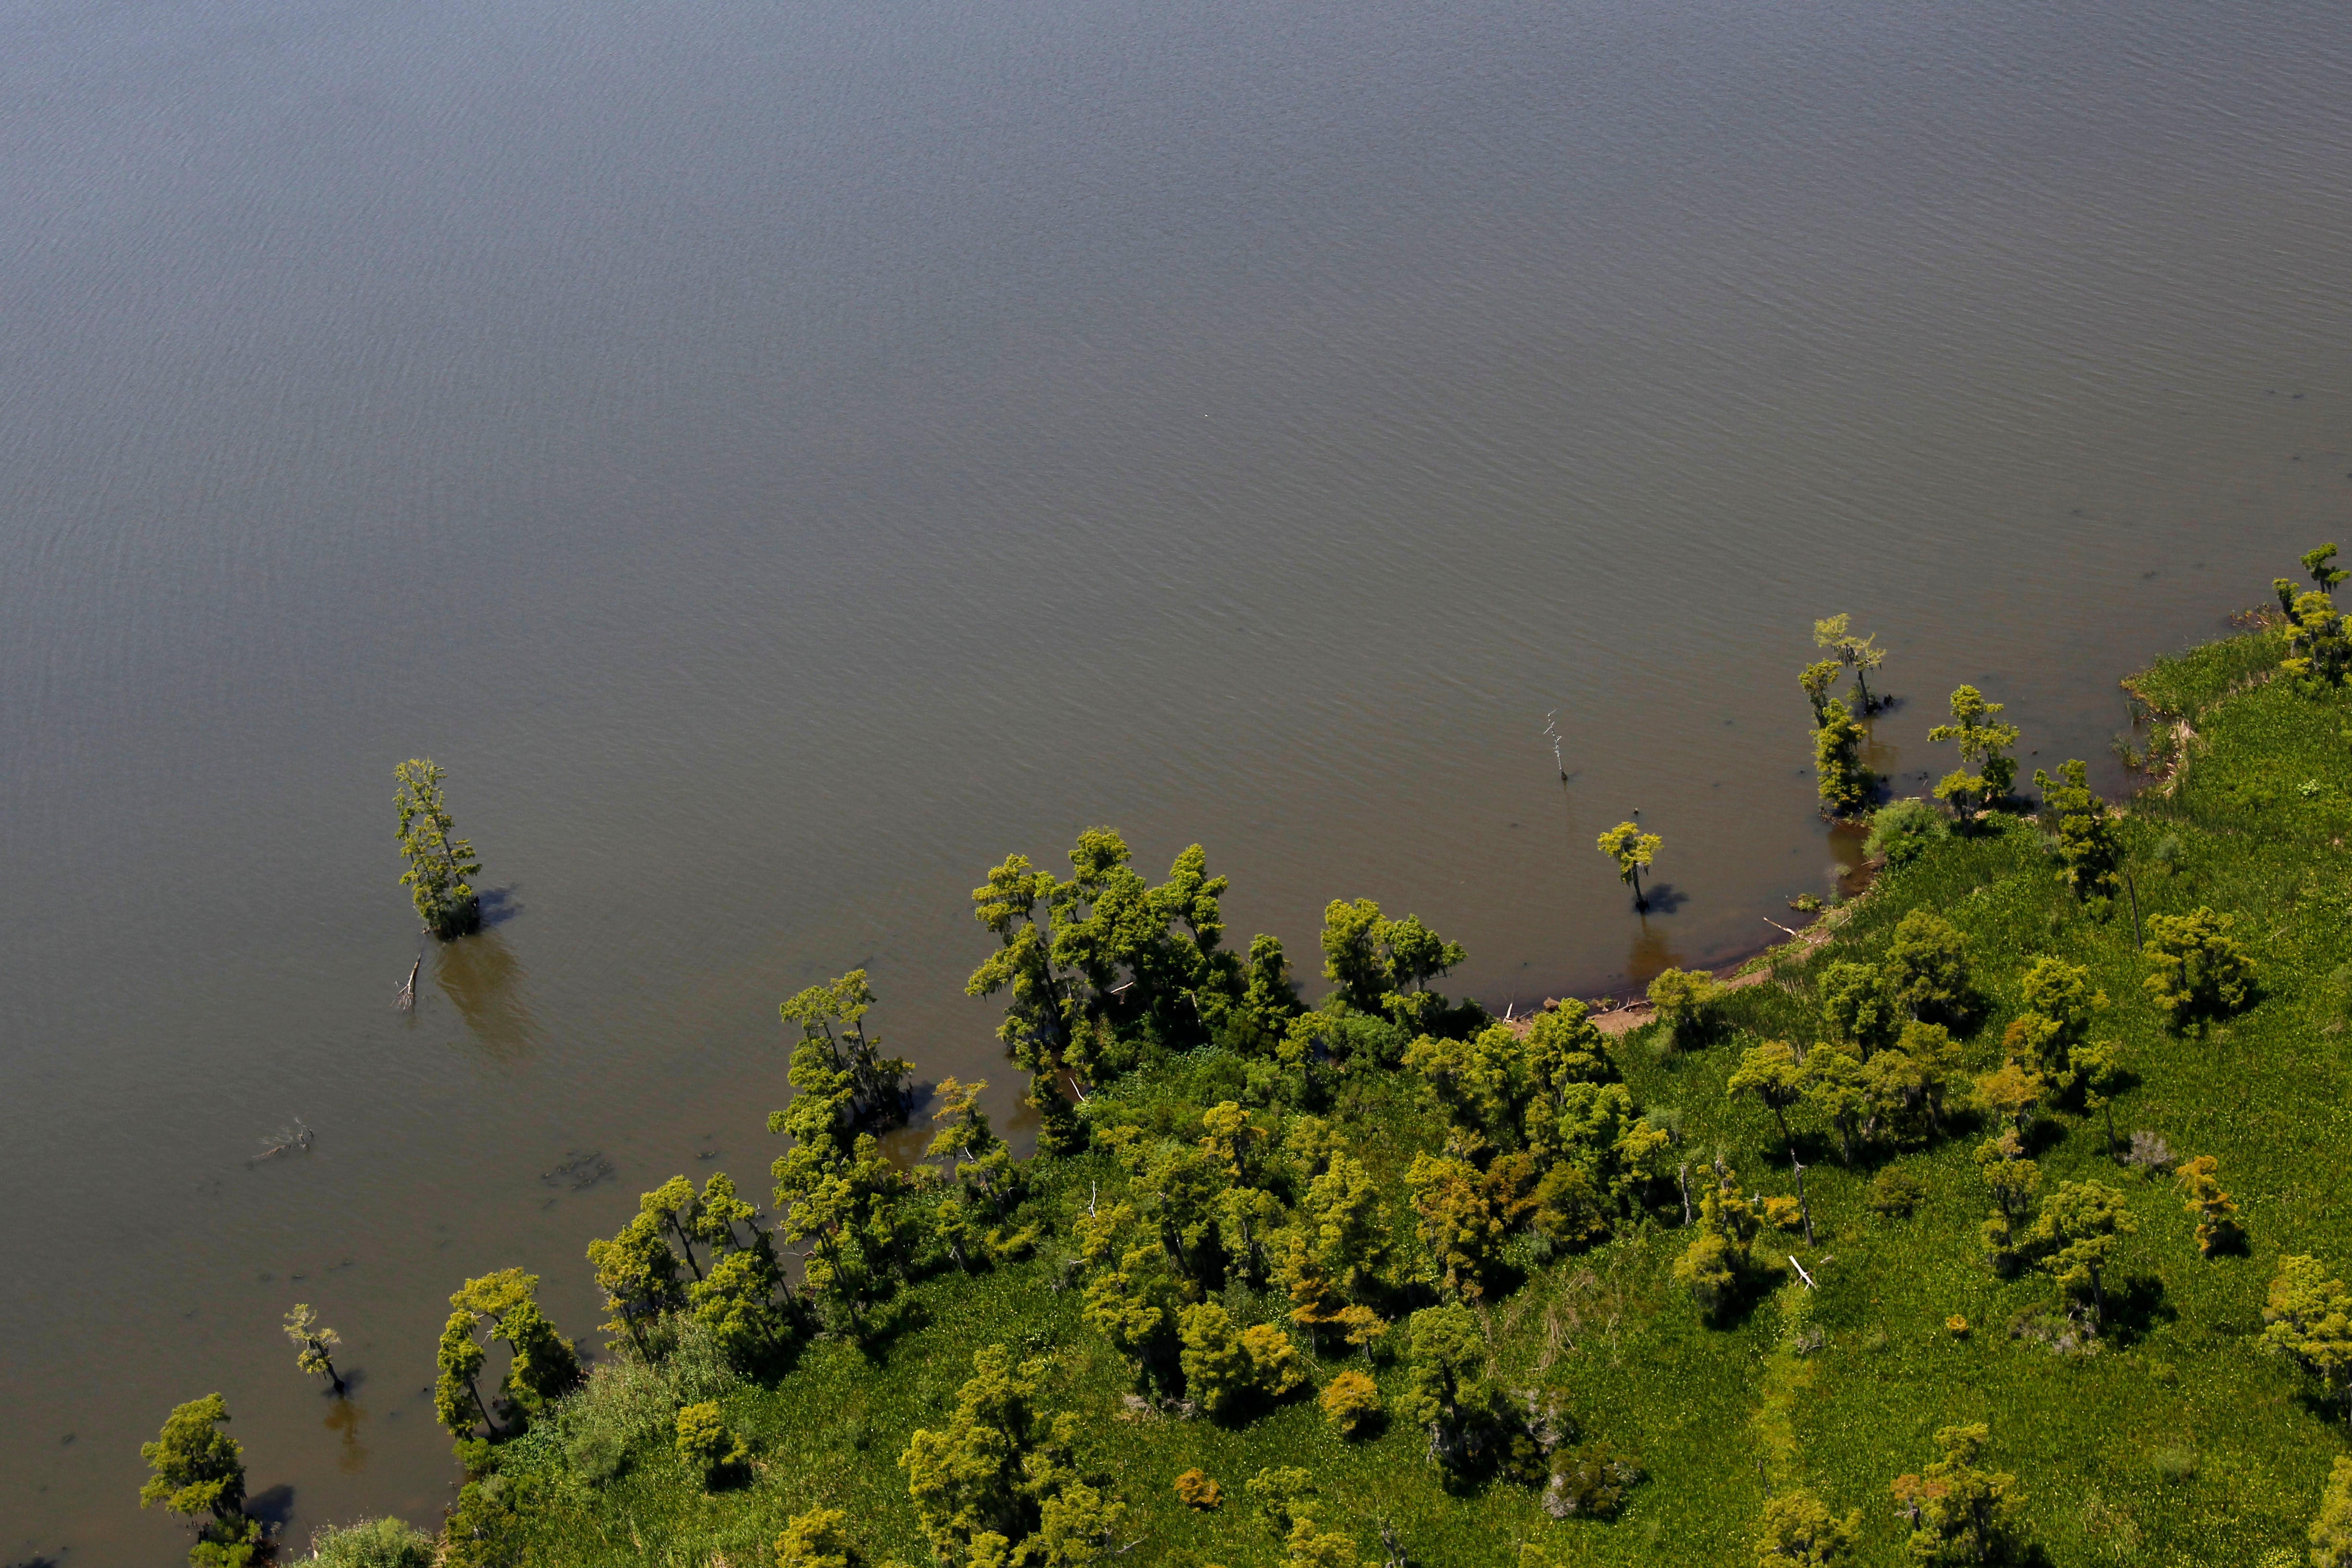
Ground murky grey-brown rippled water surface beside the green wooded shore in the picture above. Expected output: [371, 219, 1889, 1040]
[0, 0, 2352, 1568]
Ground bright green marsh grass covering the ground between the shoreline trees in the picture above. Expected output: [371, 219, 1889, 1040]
[473, 637, 2352, 1568]
